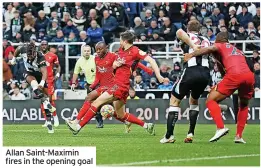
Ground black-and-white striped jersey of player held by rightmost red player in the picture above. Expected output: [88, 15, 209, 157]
[181, 33, 210, 68]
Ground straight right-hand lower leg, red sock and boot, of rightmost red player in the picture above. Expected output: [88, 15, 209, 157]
[234, 98, 248, 144]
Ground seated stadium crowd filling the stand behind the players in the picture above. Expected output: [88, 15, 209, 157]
[2, 2, 260, 100]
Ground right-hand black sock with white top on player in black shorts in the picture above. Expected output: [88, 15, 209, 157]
[188, 105, 199, 135]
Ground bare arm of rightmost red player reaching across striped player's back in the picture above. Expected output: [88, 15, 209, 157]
[184, 45, 218, 62]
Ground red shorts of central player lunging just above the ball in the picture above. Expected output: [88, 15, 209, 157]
[107, 84, 129, 104]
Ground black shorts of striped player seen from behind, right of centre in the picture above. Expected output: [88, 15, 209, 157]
[171, 66, 210, 100]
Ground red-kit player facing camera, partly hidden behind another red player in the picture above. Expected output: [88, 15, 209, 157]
[68, 41, 153, 133]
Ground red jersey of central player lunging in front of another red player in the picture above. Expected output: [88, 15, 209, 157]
[114, 46, 147, 86]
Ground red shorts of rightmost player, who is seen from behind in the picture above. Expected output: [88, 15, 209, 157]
[216, 72, 255, 99]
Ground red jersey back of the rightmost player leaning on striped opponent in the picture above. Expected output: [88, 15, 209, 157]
[215, 43, 251, 74]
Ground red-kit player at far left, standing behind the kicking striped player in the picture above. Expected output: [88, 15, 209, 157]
[41, 40, 61, 127]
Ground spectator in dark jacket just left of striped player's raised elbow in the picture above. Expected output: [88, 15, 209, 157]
[160, 17, 177, 41]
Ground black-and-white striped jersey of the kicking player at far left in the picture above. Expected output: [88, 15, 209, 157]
[19, 46, 46, 72]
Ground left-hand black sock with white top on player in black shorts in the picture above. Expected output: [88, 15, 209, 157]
[165, 106, 180, 139]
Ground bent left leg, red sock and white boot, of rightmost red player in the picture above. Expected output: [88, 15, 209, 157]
[206, 90, 229, 142]
